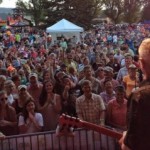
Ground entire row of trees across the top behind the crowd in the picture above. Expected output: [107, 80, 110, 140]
[14, 0, 149, 26]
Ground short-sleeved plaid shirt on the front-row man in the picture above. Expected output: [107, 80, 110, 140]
[76, 93, 105, 125]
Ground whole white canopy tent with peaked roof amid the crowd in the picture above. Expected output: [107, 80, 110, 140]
[46, 19, 84, 44]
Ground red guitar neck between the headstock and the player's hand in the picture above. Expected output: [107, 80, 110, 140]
[82, 121, 122, 140]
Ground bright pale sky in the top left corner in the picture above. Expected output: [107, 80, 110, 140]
[0, 0, 28, 8]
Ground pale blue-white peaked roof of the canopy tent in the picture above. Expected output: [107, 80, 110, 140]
[46, 19, 83, 33]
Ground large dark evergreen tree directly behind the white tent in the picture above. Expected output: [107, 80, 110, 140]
[43, 0, 102, 28]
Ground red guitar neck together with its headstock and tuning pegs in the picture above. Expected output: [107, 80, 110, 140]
[59, 114, 122, 140]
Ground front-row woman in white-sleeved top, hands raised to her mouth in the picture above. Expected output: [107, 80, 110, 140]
[18, 99, 43, 134]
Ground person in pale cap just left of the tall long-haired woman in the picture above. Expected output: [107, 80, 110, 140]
[27, 73, 43, 106]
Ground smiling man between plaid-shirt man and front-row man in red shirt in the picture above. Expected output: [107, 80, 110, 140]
[100, 80, 116, 108]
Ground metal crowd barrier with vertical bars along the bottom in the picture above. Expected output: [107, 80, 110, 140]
[0, 129, 119, 150]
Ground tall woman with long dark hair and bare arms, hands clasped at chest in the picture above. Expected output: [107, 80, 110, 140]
[39, 81, 61, 131]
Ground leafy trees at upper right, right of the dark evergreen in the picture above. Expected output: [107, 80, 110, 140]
[103, 0, 144, 23]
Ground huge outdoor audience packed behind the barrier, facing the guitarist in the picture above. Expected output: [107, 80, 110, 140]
[0, 24, 150, 144]
